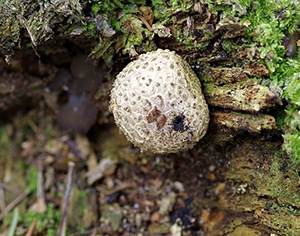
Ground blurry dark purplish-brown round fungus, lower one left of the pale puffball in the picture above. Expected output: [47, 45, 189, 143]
[57, 95, 98, 133]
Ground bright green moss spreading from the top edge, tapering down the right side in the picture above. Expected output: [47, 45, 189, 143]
[199, 0, 300, 164]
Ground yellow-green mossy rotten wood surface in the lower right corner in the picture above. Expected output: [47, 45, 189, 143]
[225, 139, 300, 235]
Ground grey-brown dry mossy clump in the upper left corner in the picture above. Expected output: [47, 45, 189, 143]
[0, 0, 82, 55]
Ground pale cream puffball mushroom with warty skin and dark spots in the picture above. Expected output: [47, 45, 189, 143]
[109, 49, 209, 153]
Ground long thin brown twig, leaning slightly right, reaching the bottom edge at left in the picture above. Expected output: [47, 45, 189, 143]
[57, 162, 75, 236]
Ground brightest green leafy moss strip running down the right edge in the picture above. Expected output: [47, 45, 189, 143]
[248, 0, 300, 163]
